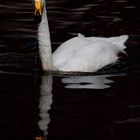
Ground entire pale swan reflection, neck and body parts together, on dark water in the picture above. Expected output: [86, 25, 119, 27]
[38, 75, 123, 139]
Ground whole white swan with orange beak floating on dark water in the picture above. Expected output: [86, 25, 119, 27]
[34, 0, 128, 72]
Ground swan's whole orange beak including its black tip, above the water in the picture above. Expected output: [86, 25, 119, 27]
[34, 0, 43, 23]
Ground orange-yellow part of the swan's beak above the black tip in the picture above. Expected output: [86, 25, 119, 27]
[34, 0, 42, 16]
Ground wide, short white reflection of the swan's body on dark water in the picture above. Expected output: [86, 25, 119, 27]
[62, 75, 120, 89]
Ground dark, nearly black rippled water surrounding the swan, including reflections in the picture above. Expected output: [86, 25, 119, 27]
[0, 0, 140, 140]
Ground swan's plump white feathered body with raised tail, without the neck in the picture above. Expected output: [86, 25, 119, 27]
[53, 34, 128, 72]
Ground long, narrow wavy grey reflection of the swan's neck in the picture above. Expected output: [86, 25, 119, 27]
[38, 76, 53, 137]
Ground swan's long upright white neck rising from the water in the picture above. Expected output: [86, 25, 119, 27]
[38, 4, 53, 71]
